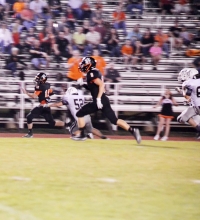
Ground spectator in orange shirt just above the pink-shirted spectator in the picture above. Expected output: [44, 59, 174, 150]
[154, 28, 169, 58]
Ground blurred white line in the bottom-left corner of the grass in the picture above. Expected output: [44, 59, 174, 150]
[0, 203, 39, 220]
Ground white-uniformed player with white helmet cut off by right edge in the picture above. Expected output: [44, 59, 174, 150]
[176, 68, 200, 134]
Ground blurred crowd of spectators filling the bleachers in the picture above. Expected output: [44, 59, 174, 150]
[0, 0, 200, 80]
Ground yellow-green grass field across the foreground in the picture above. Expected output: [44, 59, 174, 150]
[0, 138, 200, 220]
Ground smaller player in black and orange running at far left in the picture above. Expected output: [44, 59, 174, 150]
[22, 72, 65, 138]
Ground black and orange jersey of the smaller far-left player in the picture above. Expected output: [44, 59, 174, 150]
[34, 83, 53, 104]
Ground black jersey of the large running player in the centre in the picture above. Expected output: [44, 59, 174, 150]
[87, 69, 103, 99]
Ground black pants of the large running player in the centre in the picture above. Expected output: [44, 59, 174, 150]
[76, 95, 118, 125]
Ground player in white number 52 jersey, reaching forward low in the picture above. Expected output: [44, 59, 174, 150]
[48, 87, 108, 139]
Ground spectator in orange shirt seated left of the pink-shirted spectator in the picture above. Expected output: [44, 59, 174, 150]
[121, 40, 137, 69]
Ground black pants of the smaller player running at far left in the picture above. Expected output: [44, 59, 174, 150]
[26, 106, 55, 126]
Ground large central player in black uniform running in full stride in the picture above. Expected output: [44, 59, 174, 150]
[73, 57, 141, 143]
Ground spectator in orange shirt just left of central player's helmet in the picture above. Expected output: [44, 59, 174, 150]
[67, 50, 83, 81]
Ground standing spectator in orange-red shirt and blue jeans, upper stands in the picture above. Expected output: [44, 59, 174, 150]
[113, 6, 126, 35]
